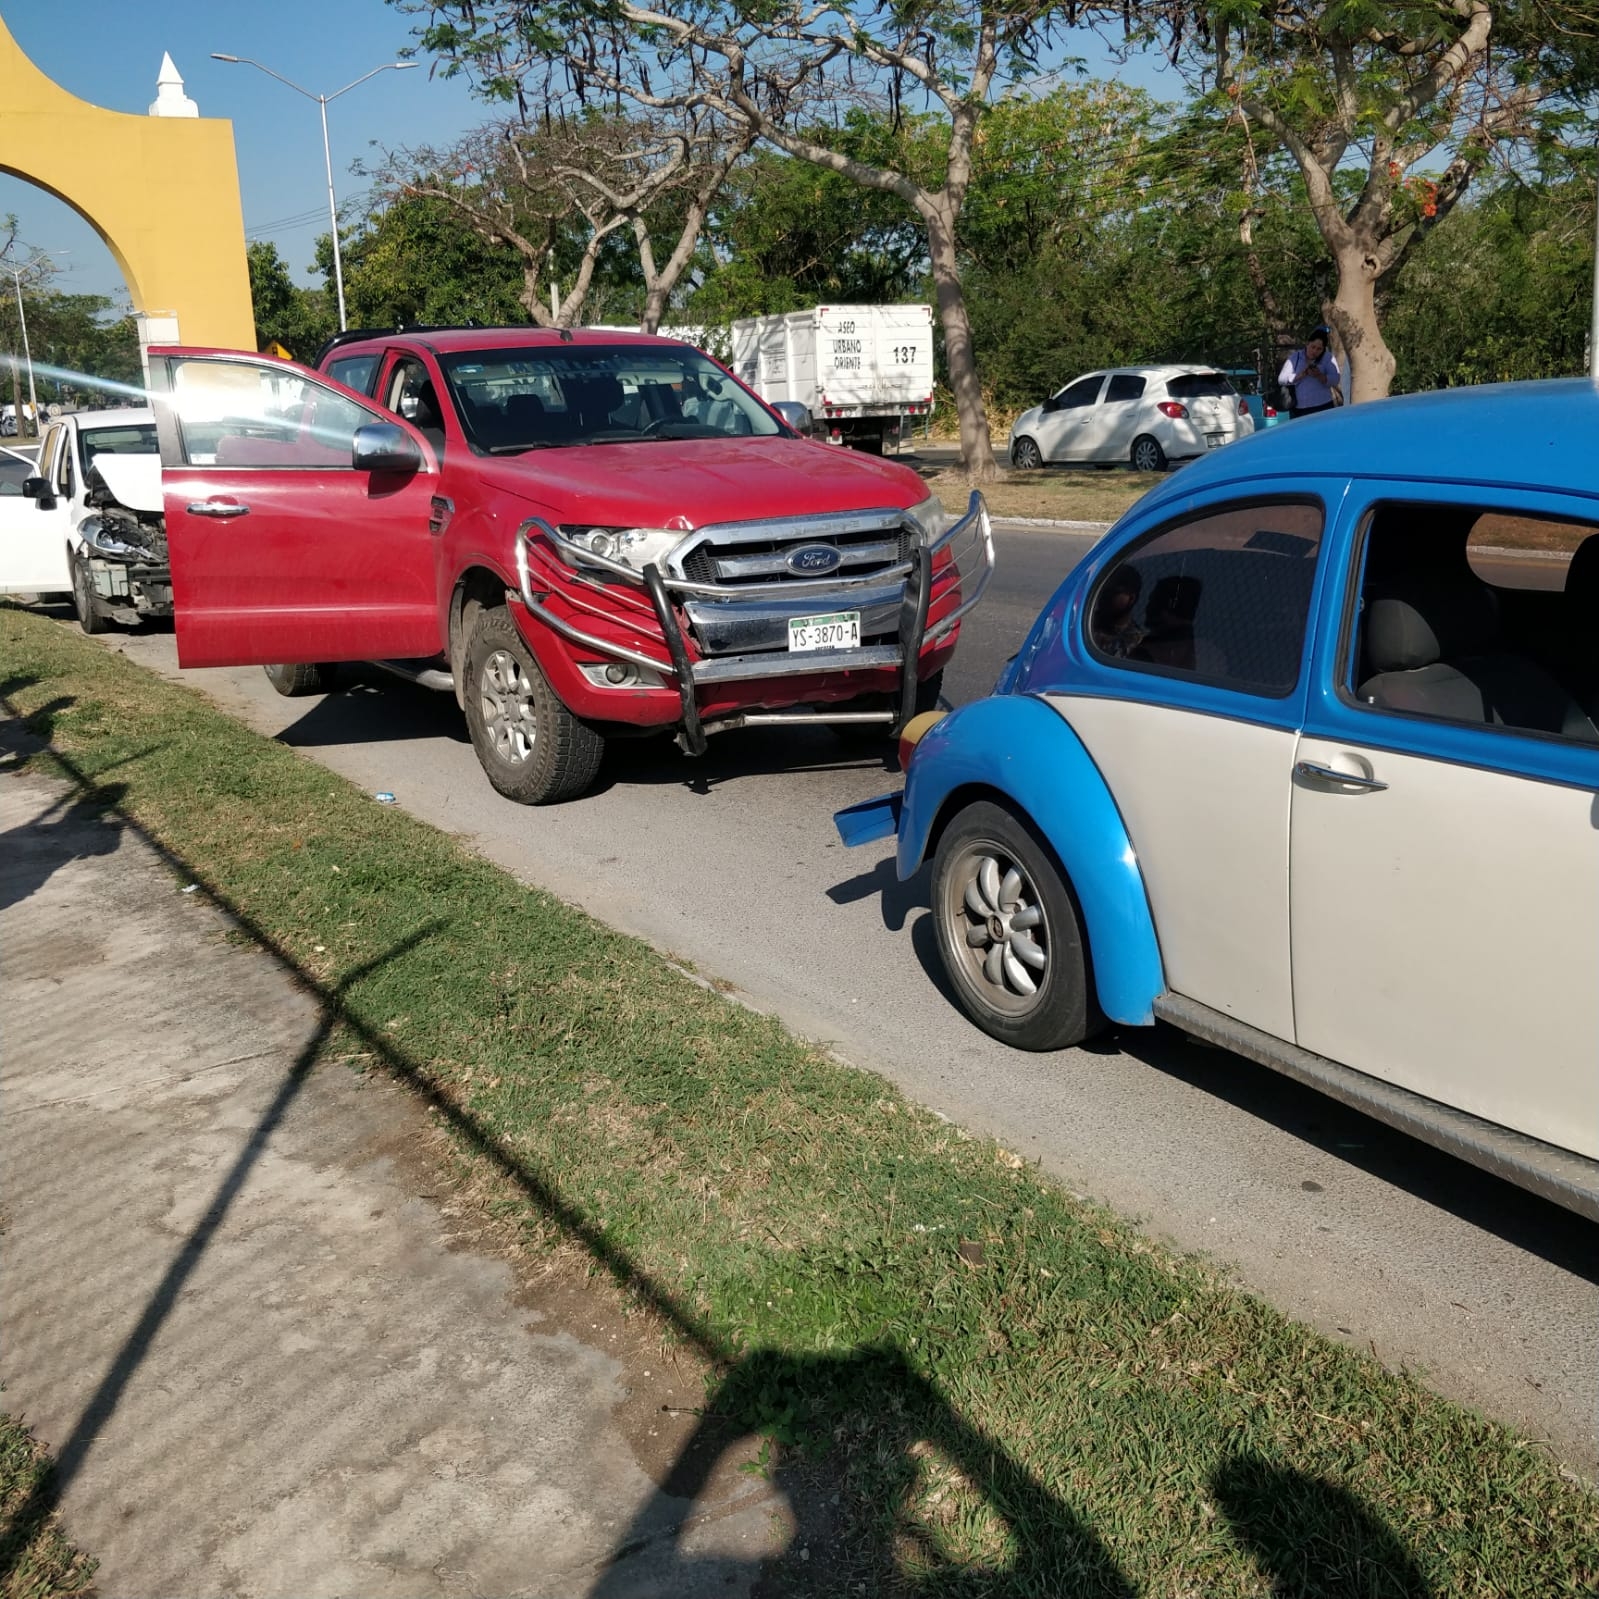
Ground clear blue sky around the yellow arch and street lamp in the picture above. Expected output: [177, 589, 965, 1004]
[0, 0, 1174, 304]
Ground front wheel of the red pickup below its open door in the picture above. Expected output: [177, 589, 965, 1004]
[462, 606, 604, 804]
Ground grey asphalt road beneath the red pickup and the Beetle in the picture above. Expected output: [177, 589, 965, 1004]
[87, 524, 1599, 1473]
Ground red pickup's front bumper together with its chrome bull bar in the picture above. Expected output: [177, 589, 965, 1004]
[516, 492, 995, 753]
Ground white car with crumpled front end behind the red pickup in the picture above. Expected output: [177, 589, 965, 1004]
[0, 408, 173, 633]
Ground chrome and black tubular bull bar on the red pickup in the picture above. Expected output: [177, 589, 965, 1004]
[516, 489, 995, 755]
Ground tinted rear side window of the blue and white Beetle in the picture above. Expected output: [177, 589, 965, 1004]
[1087, 500, 1322, 697]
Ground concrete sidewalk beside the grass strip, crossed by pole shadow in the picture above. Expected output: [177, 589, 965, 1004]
[0, 721, 786, 1599]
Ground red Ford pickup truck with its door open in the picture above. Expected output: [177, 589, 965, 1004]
[150, 328, 993, 804]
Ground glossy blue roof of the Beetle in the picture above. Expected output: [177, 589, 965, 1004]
[1138, 377, 1599, 508]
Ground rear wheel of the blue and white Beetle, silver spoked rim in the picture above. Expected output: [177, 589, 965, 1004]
[932, 800, 1103, 1051]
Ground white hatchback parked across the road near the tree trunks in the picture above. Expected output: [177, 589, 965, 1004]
[1011, 366, 1255, 472]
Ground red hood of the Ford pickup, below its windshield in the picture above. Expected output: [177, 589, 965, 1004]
[483, 438, 929, 531]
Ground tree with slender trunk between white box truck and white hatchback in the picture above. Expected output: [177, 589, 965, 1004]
[392, 0, 1070, 480]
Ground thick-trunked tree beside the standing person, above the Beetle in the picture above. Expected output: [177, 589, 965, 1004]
[1138, 0, 1594, 400]
